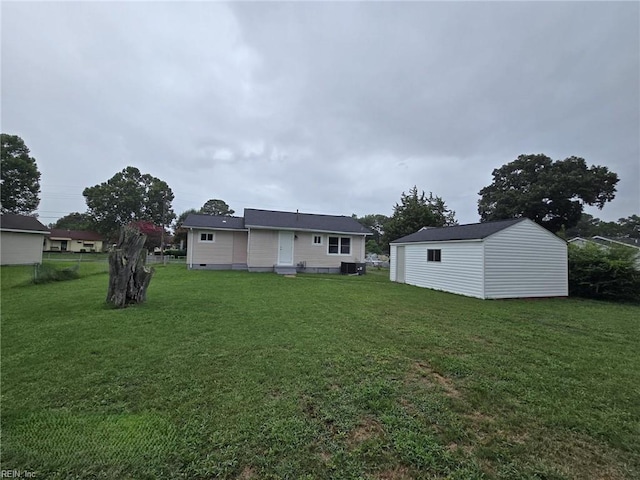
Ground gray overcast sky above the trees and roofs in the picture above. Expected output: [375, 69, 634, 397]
[1, 1, 640, 224]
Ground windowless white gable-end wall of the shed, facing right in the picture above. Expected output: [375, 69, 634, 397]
[484, 221, 569, 298]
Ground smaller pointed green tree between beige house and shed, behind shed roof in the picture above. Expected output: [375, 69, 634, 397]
[384, 186, 457, 243]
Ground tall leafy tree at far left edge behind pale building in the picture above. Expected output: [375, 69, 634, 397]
[0, 133, 40, 215]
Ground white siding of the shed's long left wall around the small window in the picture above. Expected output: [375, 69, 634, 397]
[405, 241, 483, 298]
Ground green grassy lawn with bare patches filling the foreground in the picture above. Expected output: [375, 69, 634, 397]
[1, 263, 640, 480]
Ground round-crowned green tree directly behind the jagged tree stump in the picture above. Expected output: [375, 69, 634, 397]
[82, 167, 175, 239]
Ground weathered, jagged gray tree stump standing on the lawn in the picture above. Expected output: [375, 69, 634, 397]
[107, 226, 154, 308]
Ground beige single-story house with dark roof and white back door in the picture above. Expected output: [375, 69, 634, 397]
[182, 208, 371, 273]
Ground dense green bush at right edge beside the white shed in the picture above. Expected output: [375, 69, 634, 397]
[569, 243, 640, 301]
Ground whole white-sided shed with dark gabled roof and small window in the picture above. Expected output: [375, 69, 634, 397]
[390, 218, 569, 298]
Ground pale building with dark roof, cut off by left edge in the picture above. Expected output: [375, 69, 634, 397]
[0, 213, 49, 265]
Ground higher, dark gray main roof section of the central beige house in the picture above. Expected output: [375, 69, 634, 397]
[244, 208, 372, 235]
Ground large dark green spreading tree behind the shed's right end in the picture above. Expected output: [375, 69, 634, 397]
[478, 154, 618, 232]
